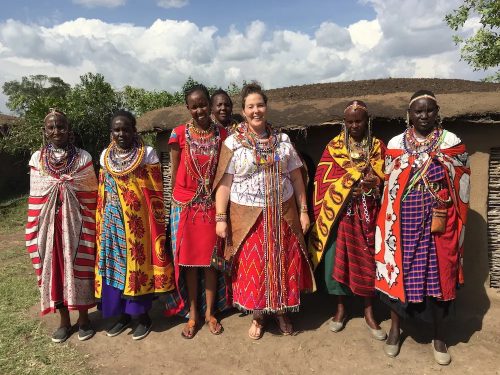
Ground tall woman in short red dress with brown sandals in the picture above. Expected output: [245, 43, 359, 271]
[167, 85, 231, 339]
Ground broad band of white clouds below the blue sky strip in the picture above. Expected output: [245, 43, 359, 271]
[0, 0, 492, 111]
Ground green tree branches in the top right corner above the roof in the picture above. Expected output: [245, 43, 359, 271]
[445, 0, 500, 82]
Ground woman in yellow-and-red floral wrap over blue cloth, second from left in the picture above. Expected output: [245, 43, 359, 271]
[95, 110, 174, 340]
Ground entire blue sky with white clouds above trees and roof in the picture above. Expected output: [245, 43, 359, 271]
[0, 0, 488, 113]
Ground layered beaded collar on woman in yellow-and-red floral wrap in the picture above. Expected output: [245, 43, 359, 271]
[104, 137, 145, 177]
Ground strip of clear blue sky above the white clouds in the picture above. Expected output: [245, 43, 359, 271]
[0, 0, 375, 33]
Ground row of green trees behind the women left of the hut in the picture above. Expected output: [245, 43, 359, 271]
[0, 73, 240, 163]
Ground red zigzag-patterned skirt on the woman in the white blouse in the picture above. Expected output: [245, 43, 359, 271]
[232, 214, 309, 313]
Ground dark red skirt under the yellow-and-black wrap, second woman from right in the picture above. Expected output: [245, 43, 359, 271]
[330, 197, 378, 297]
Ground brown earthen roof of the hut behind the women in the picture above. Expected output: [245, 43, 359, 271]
[137, 78, 500, 132]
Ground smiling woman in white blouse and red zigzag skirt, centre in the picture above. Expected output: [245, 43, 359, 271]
[214, 83, 315, 339]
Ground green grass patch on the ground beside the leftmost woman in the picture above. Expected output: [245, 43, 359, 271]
[0, 198, 93, 375]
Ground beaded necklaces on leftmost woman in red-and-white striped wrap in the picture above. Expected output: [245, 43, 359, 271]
[40, 143, 80, 178]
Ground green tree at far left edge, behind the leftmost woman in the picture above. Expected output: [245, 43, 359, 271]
[0, 75, 71, 154]
